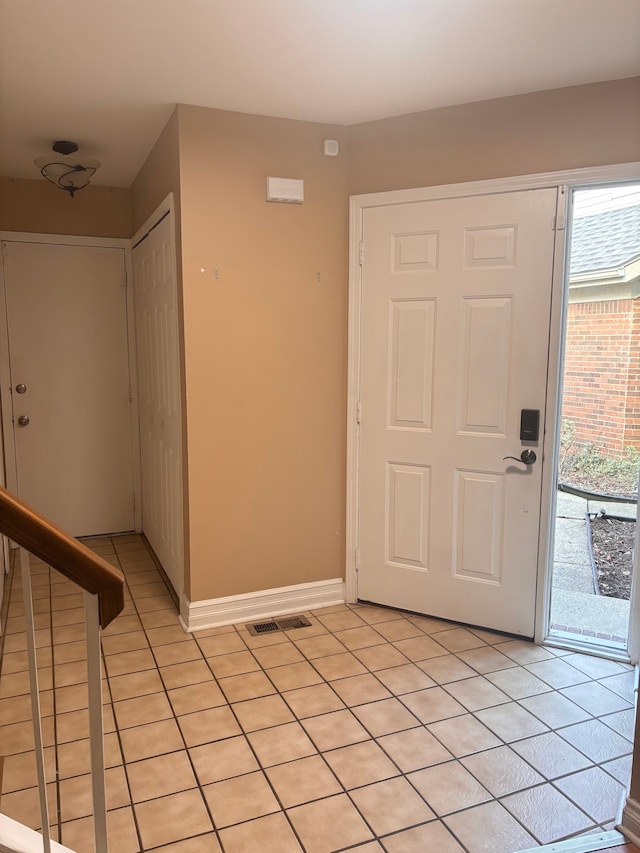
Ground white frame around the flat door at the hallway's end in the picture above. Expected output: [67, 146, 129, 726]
[0, 231, 142, 532]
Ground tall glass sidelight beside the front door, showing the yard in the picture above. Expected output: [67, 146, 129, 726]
[549, 183, 640, 656]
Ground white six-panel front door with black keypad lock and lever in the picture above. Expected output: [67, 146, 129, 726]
[358, 189, 556, 637]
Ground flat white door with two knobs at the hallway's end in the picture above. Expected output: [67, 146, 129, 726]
[3, 242, 134, 536]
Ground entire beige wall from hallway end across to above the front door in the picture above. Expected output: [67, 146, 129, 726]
[5, 78, 640, 600]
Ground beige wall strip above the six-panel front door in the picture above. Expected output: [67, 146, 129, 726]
[349, 77, 640, 194]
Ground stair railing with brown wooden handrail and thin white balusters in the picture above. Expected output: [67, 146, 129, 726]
[0, 486, 124, 853]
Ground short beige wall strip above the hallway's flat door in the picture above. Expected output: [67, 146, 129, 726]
[0, 178, 131, 238]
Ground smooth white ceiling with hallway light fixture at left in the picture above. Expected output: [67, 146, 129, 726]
[0, 0, 640, 186]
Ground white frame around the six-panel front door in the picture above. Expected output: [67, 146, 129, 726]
[345, 162, 640, 649]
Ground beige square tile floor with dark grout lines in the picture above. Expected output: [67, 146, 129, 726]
[0, 535, 635, 853]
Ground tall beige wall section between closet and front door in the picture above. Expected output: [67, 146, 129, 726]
[179, 106, 347, 600]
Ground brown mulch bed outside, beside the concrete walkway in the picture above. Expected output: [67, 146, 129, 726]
[589, 515, 636, 601]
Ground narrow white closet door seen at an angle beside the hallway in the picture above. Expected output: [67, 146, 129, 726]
[133, 214, 184, 594]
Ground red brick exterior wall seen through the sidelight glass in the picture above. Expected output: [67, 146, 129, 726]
[562, 298, 640, 456]
